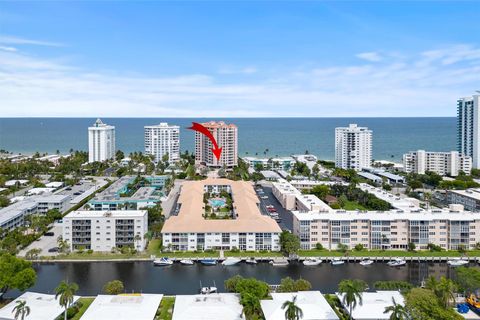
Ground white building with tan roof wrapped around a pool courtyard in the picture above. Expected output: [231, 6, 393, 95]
[162, 178, 281, 251]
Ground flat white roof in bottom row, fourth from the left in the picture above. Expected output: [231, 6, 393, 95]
[260, 291, 338, 320]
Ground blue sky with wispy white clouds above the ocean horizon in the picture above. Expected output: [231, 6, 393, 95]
[0, 1, 480, 118]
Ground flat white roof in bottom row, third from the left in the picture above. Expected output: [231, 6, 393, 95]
[172, 293, 245, 320]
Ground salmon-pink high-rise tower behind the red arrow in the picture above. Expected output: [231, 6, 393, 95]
[195, 121, 238, 168]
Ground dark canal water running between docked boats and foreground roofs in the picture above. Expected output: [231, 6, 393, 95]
[7, 262, 466, 297]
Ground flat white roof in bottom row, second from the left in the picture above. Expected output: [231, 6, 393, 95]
[80, 294, 163, 320]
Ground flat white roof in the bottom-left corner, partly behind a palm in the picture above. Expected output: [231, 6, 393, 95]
[0, 292, 79, 320]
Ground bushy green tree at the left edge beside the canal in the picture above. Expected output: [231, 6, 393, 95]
[0, 253, 37, 297]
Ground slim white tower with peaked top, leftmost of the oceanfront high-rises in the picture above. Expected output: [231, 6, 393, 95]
[88, 119, 115, 162]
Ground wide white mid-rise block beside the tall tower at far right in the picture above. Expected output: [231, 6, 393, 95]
[403, 150, 472, 177]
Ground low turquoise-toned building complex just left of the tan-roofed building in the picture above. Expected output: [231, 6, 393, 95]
[87, 176, 169, 211]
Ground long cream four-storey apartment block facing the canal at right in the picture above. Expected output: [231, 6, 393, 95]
[293, 207, 480, 250]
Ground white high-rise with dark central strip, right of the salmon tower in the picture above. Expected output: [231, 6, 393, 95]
[335, 124, 372, 171]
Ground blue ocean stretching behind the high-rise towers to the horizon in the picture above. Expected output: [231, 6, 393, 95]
[0, 117, 456, 161]
